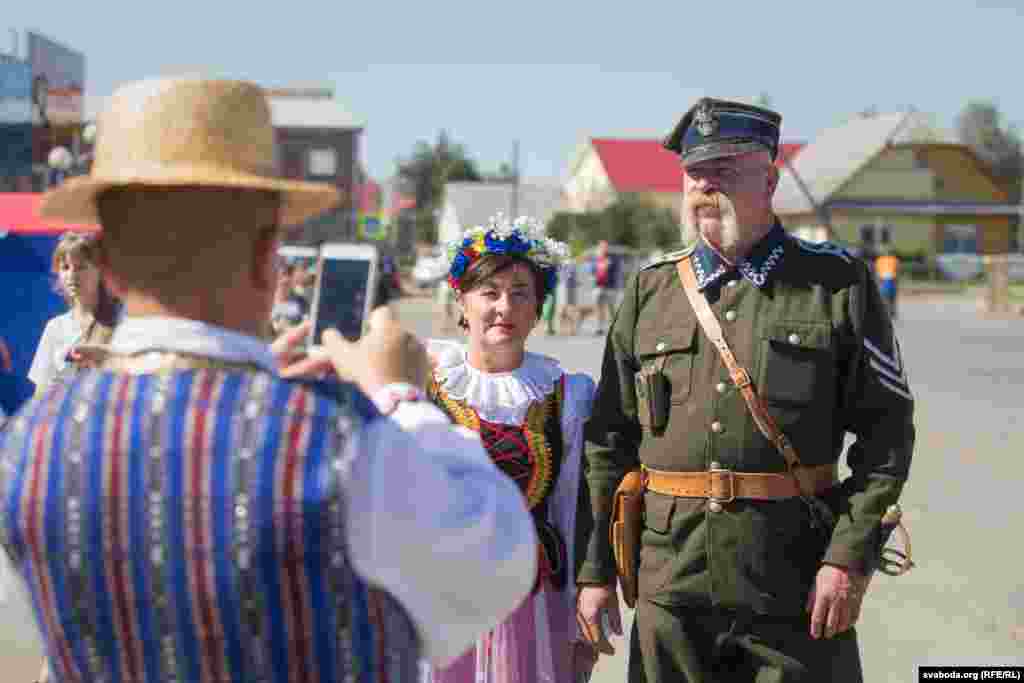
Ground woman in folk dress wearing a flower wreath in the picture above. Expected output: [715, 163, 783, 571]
[425, 216, 596, 683]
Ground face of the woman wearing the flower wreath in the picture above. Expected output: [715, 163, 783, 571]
[460, 263, 539, 348]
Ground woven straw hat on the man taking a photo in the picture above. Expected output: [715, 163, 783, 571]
[39, 78, 339, 225]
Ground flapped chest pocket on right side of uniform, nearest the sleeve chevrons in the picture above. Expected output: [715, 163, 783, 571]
[758, 323, 836, 408]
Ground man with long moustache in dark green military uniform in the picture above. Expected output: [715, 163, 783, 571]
[579, 99, 914, 683]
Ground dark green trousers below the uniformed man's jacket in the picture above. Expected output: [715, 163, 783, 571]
[629, 600, 863, 683]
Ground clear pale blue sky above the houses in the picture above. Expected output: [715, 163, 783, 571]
[0, 0, 1024, 179]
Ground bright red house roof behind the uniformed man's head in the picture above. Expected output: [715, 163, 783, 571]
[591, 137, 804, 193]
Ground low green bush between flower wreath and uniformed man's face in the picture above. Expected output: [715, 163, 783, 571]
[548, 195, 680, 254]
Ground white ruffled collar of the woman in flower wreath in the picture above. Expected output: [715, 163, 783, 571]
[430, 342, 563, 425]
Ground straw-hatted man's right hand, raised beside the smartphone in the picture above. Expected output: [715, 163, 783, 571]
[274, 306, 430, 396]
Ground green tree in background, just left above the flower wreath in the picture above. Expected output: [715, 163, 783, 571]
[398, 130, 482, 242]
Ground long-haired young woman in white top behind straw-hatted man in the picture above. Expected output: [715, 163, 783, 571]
[29, 232, 119, 391]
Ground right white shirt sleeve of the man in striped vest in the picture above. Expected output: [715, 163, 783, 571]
[346, 402, 537, 666]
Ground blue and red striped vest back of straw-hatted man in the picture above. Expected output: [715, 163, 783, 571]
[0, 369, 420, 683]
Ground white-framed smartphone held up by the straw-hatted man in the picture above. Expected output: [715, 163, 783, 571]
[308, 243, 380, 351]
